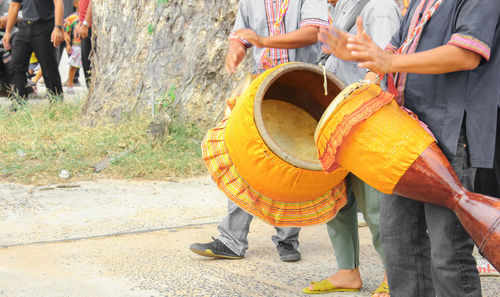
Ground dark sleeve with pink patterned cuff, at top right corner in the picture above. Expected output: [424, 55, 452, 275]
[448, 0, 500, 61]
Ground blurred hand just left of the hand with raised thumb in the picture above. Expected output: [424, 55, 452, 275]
[318, 27, 354, 61]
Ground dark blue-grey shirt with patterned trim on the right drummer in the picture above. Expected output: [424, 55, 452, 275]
[391, 0, 500, 168]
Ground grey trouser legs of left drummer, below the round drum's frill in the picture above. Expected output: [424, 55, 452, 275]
[217, 199, 300, 256]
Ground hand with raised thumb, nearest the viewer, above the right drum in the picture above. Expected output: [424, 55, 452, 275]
[347, 17, 394, 74]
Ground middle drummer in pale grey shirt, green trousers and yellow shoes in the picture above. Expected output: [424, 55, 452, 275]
[303, 0, 401, 297]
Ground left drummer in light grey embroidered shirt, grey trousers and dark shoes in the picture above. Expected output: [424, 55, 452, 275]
[190, 0, 328, 262]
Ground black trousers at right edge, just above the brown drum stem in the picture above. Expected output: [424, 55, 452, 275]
[474, 109, 500, 198]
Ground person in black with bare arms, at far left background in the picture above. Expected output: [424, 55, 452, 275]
[3, 0, 64, 99]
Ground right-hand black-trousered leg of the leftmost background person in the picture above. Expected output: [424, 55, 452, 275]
[31, 22, 63, 98]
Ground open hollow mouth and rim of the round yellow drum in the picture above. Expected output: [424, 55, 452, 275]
[254, 63, 345, 171]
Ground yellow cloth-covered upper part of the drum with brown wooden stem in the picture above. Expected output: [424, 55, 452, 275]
[315, 83, 434, 194]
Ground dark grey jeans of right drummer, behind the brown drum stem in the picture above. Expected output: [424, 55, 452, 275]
[380, 123, 481, 297]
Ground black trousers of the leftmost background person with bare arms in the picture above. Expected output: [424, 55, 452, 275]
[10, 20, 63, 98]
